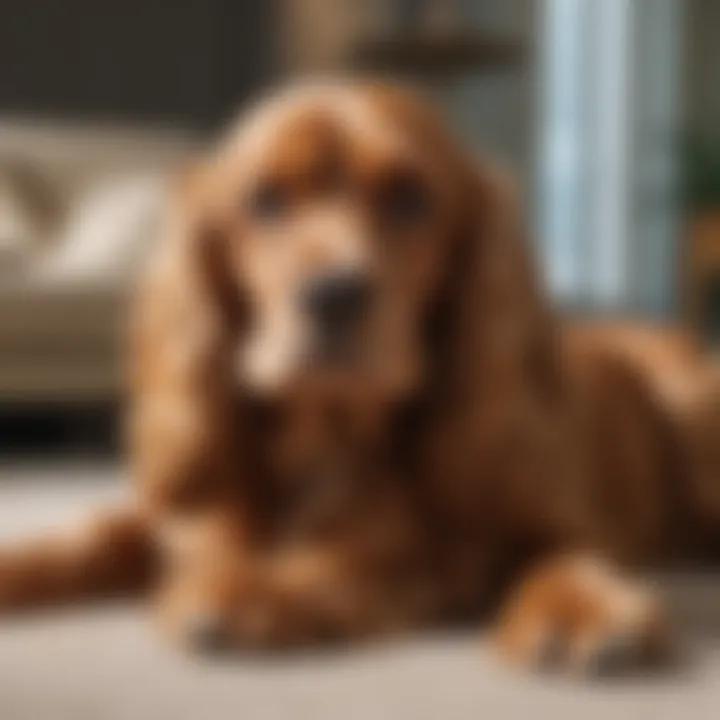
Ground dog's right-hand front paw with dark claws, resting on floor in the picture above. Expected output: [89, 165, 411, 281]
[495, 556, 670, 676]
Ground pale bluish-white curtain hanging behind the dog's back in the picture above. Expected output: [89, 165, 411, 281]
[537, 0, 682, 314]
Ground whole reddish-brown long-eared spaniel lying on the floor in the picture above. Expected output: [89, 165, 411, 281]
[0, 85, 720, 667]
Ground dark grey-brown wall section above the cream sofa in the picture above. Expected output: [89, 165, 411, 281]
[0, 0, 274, 125]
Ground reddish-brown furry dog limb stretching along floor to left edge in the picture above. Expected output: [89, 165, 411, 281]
[0, 509, 156, 612]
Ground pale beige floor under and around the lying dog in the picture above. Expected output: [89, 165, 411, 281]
[0, 463, 720, 720]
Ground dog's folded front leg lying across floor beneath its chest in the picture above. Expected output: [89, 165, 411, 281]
[157, 523, 432, 652]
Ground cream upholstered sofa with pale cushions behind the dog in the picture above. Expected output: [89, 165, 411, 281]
[0, 120, 197, 406]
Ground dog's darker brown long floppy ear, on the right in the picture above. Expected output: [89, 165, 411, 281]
[424, 159, 563, 517]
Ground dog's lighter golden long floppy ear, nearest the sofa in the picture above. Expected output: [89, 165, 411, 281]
[129, 167, 249, 507]
